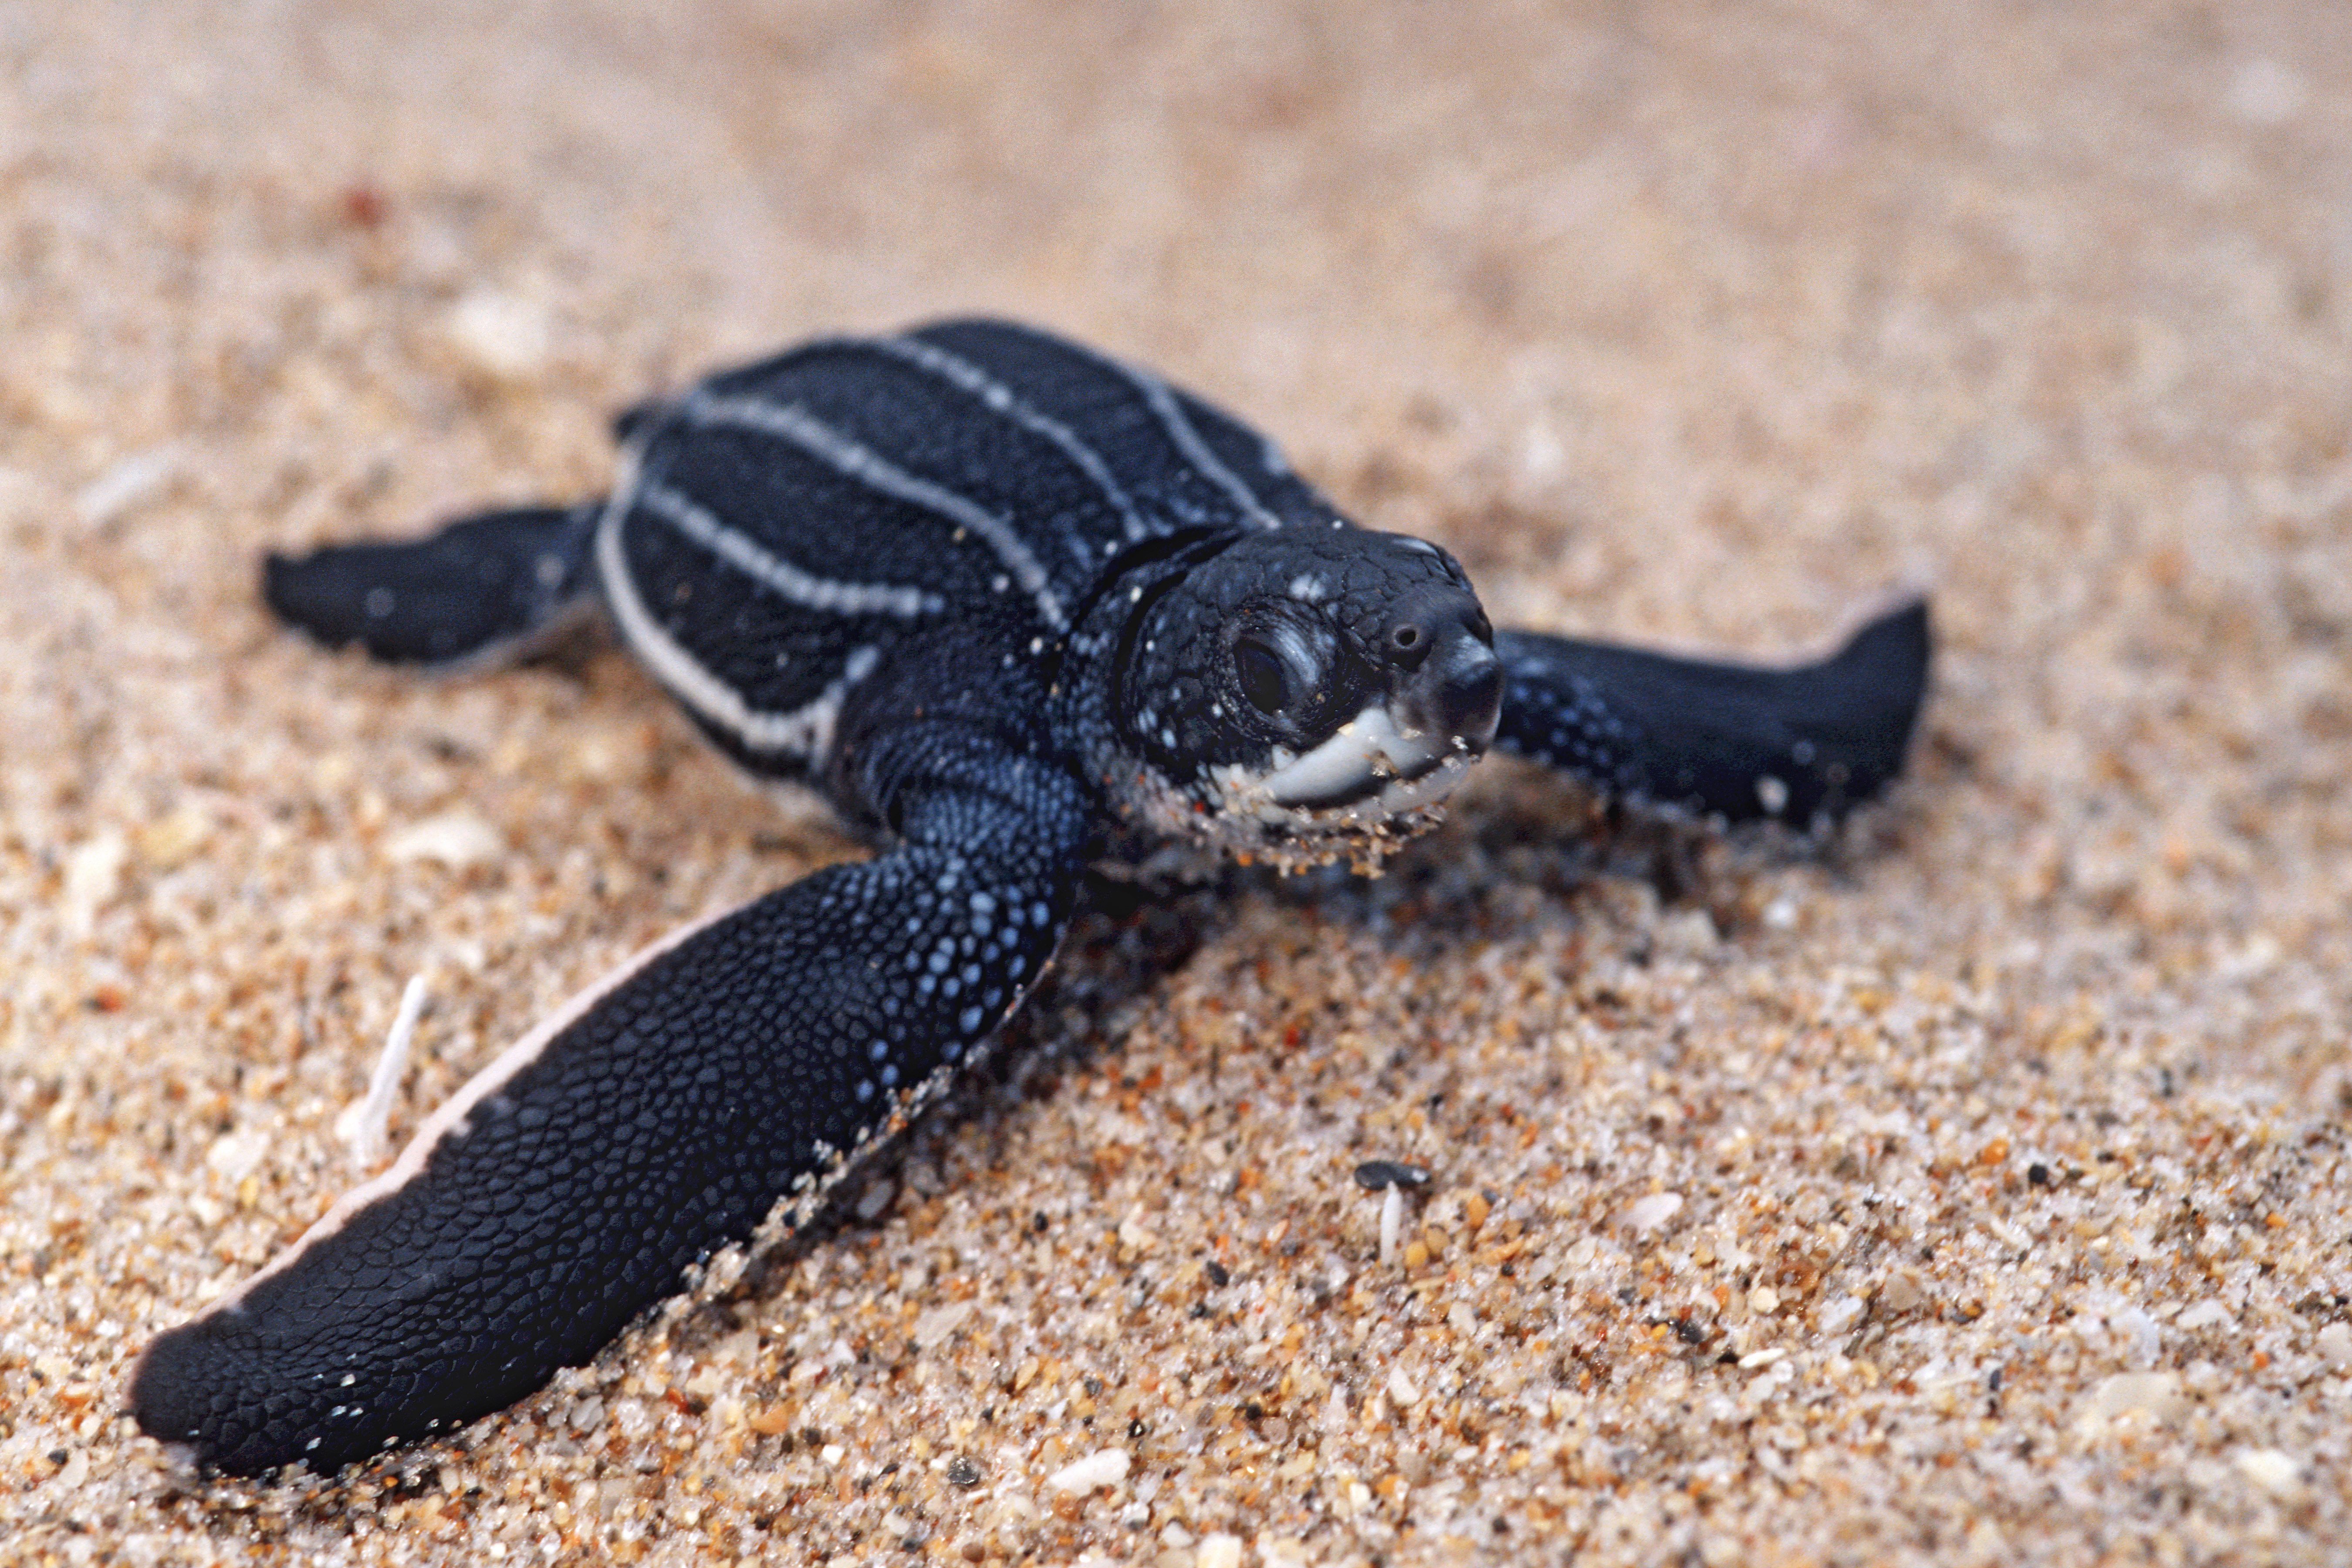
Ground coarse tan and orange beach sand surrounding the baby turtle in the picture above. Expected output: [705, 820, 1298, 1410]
[0, 0, 2352, 1568]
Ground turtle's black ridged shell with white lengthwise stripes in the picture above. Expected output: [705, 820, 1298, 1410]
[595, 322, 1338, 776]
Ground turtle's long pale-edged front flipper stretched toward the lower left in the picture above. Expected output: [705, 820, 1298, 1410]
[132, 736, 1089, 1474]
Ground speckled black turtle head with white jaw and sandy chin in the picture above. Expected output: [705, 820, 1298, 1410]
[1117, 527, 1503, 865]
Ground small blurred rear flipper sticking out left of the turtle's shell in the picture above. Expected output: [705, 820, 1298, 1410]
[261, 503, 600, 665]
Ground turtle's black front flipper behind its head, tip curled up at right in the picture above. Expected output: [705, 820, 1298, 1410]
[1494, 599, 1931, 828]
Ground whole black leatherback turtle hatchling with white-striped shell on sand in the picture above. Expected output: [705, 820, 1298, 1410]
[132, 322, 1929, 1474]
